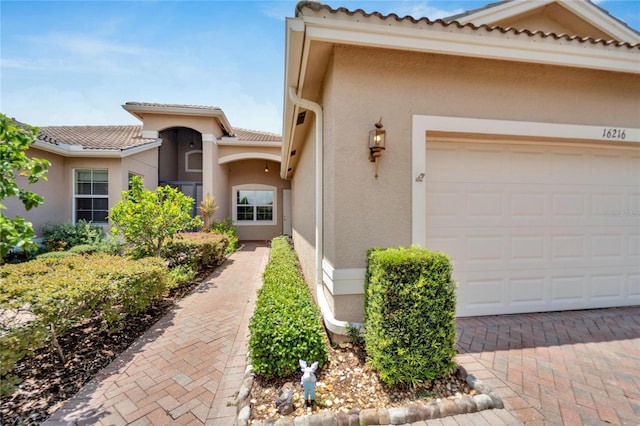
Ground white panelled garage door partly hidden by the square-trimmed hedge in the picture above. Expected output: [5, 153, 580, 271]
[425, 140, 640, 316]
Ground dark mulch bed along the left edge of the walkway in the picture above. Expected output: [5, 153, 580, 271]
[0, 267, 215, 426]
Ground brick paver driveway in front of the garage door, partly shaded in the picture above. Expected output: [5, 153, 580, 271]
[457, 307, 640, 425]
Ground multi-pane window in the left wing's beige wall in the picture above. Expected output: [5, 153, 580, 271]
[73, 169, 109, 223]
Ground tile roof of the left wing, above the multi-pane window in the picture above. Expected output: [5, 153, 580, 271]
[38, 126, 157, 150]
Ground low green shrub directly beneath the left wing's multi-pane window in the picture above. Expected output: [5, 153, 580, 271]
[42, 219, 105, 251]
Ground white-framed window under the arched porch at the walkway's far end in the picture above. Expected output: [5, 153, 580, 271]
[233, 185, 276, 225]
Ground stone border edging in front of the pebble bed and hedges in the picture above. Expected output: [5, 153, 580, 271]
[235, 364, 504, 426]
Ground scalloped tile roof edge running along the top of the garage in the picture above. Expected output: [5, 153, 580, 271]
[296, 1, 640, 50]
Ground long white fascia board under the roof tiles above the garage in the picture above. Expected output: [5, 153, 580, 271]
[306, 17, 640, 74]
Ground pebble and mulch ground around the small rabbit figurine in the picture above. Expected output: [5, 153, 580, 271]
[248, 343, 477, 422]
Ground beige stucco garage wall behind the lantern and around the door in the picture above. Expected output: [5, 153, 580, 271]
[293, 46, 640, 321]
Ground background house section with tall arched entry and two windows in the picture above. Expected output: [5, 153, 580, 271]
[5, 102, 290, 240]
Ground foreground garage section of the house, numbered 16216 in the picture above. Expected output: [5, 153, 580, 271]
[281, 0, 640, 335]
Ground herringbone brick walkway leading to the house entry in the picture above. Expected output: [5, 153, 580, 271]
[45, 243, 269, 426]
